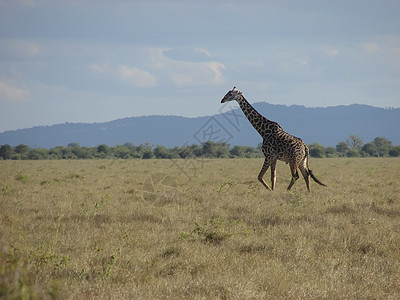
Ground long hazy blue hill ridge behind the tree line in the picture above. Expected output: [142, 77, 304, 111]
[0, 102, 400, 148]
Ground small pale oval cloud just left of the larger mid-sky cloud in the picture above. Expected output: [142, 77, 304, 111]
[118, 65, 157, 88]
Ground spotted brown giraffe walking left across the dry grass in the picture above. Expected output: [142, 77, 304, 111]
[221, 87, 325, 191]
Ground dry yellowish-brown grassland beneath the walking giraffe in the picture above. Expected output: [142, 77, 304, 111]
[0, 158, 400, 299]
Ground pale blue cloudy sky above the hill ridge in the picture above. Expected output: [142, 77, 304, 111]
[0, 0, 400, 132]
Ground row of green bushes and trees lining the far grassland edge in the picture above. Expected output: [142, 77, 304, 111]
[0, 136, 400, 160]
